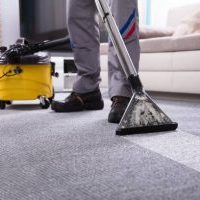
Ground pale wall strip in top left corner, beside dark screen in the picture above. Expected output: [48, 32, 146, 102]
[0, 0, 20, 46]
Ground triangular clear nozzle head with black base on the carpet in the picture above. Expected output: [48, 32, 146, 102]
[116, 91, 178, 135]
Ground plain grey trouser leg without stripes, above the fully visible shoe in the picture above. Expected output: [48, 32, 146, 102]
[68, 0, 100, 93]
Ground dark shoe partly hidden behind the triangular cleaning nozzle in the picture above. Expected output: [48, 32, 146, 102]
[108, 96, 130, 123]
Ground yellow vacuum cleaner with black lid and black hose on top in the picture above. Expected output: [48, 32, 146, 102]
[0, 38, 69, 109]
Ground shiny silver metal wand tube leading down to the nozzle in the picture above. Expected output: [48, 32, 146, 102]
[95, 0, 138, 78]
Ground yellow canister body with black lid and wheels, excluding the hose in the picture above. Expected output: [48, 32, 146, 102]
[0, 55, 53, 108]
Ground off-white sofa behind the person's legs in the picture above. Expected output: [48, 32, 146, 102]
[101, 4, 200, 94]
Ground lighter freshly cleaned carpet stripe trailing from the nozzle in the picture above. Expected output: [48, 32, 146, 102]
[125, 130, 200, 172]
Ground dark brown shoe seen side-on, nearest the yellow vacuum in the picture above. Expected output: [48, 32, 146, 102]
[51, 90, 104, 112]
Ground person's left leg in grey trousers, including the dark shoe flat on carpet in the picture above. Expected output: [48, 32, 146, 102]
[52, 0, 103, 112]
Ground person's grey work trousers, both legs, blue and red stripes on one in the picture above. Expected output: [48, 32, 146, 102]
[67, 0, 140, 97]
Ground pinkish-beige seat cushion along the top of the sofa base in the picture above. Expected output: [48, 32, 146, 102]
[140, 34, 200, 53]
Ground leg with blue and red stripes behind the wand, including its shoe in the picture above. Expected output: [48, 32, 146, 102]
[108, 0, 140, 123]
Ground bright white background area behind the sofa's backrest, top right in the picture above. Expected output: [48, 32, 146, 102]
[151, 0, 200, 27]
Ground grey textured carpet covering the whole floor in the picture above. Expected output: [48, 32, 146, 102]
[0, 91, 200, 200]
